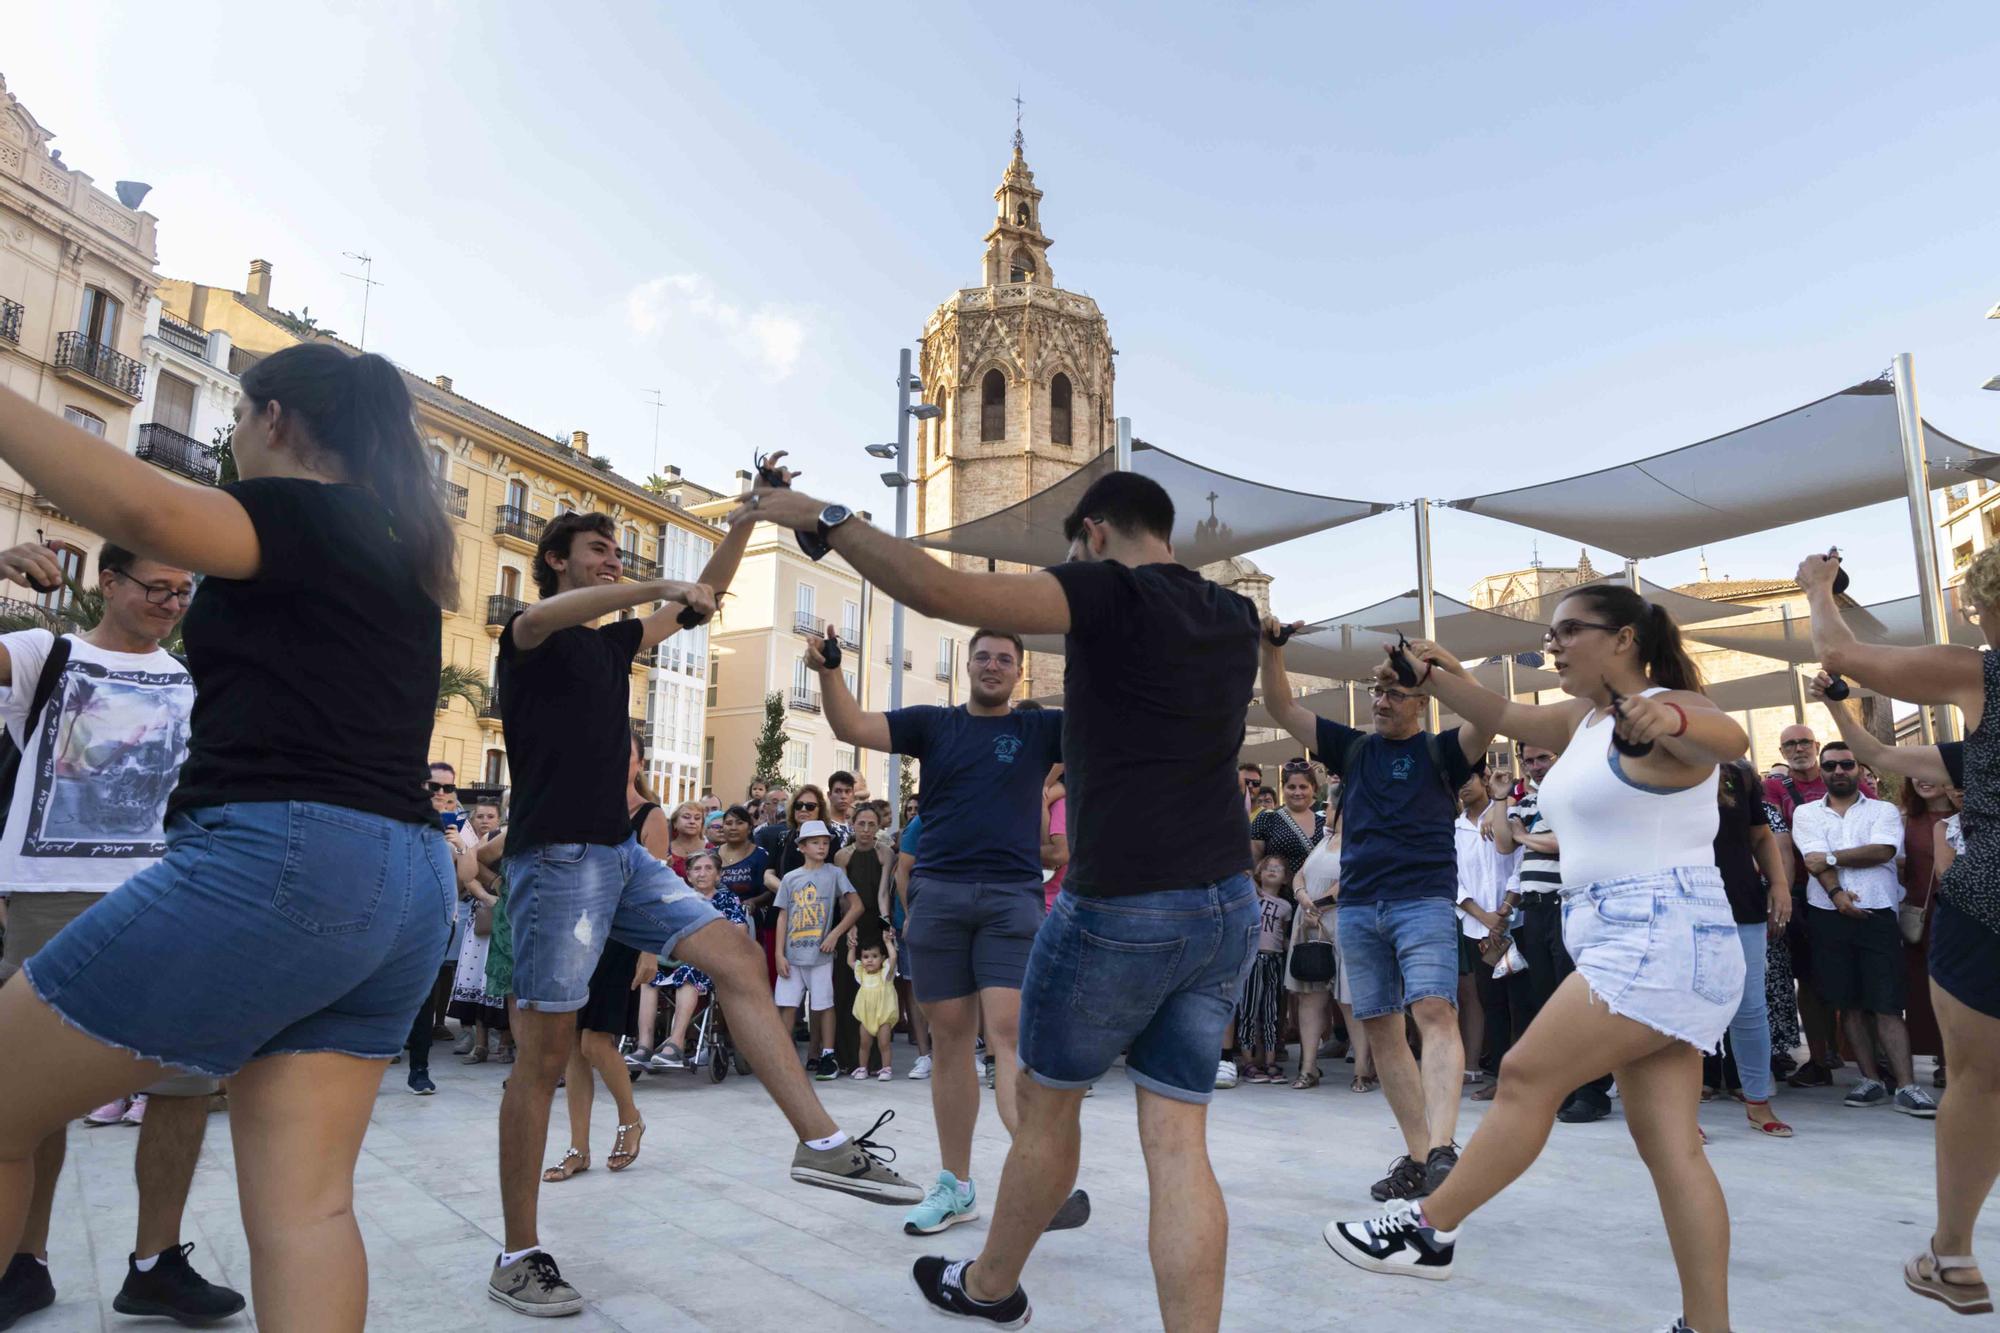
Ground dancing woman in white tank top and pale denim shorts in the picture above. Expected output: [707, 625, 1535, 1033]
[1326, 584, 1748, 1333]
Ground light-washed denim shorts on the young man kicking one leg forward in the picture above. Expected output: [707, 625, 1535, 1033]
[506, 837, 722, 1013]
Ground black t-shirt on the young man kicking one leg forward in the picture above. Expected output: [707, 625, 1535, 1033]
[500, 616, 646, 853]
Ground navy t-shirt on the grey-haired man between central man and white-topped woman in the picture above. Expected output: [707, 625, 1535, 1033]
[1312, 717, 1472, 907]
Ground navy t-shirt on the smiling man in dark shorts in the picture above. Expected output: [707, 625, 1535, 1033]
[888, 705, 1062, 883]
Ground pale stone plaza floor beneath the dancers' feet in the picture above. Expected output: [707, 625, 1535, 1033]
[43, 1045, 1968, 1333]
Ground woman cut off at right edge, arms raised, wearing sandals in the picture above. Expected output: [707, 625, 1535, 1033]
[1798, 546, 2000, 1315]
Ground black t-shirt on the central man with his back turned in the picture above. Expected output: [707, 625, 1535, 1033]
[1040, 560, 1260, 899]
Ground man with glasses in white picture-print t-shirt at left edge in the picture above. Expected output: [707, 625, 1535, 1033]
[0, 542, 244, 1327]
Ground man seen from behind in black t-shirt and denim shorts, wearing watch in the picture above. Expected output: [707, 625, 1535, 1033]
[732, 472, 1258, 1329]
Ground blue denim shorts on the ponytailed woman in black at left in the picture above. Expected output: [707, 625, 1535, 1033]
[22, 801, 458, 1079]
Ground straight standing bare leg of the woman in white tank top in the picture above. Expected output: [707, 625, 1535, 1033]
[1616, 1041, 1730, 1333]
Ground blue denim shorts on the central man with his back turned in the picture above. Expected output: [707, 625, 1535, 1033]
[1020, 875, 1262, 1103]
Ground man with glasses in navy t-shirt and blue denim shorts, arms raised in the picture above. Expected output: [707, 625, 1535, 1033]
[1264, 620, 1492, 1201]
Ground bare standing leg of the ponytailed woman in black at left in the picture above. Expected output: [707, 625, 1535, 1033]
[230, 1055, 388, 1333]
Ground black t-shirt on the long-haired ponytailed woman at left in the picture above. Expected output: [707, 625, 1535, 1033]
[166, 476, 442, 825]
